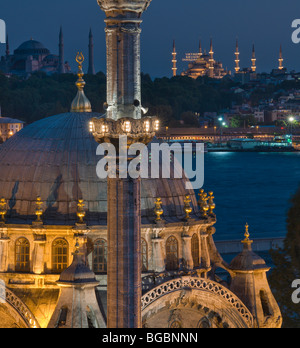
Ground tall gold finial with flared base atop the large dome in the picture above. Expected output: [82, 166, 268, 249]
[71, 52, 92, 112]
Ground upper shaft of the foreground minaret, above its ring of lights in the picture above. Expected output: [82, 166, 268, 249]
[98, 0, 151, 120]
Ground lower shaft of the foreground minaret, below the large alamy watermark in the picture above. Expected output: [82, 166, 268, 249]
[107, 170, 142, 328]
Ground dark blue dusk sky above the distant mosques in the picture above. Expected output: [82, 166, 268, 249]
[0, 0, 300, 77]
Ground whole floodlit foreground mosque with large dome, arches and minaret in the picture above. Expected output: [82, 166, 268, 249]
[0, 0, 282, 329]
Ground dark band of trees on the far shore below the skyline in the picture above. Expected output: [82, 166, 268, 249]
[0, 72, 300, 127]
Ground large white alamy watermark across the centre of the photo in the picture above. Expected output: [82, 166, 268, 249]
[96, 135, 205, 190]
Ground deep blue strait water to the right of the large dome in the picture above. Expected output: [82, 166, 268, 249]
[196, 152, 300, 240]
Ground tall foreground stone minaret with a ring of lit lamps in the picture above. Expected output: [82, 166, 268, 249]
[90, 0, 158, 328]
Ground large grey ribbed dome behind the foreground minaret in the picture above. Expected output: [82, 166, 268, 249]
[0, 113, 197, 225]
